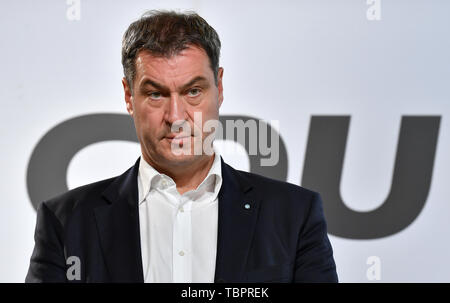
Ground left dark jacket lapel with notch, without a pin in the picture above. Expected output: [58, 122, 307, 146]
[94, 158, 144, 282]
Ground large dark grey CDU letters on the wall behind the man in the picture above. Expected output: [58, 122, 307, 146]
[27, 114, 441, 239]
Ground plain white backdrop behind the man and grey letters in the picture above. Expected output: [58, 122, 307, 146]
[0, 0, 450, 282]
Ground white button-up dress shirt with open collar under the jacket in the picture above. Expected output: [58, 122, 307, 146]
[138, 150, 222, 283]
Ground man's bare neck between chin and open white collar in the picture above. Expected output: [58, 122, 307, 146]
[146, 154, 215, 194]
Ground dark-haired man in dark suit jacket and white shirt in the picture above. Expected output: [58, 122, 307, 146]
[26, 11, 337, 282]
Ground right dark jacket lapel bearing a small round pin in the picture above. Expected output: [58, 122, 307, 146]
[214, 160, 260, 282]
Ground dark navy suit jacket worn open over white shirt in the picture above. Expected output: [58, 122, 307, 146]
[26, 159, 337, 282]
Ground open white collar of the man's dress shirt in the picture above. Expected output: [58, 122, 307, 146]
[138, 148, 222, 204]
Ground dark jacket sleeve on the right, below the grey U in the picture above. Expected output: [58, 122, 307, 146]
[294, 193, 338, 283]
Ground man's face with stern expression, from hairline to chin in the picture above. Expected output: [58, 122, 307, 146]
[122, 46, 223, 167]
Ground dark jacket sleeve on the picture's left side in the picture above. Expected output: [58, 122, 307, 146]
[25, 202, 66, 283]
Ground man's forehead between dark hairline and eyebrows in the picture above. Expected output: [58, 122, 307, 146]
[136, 46, 214, 83]
